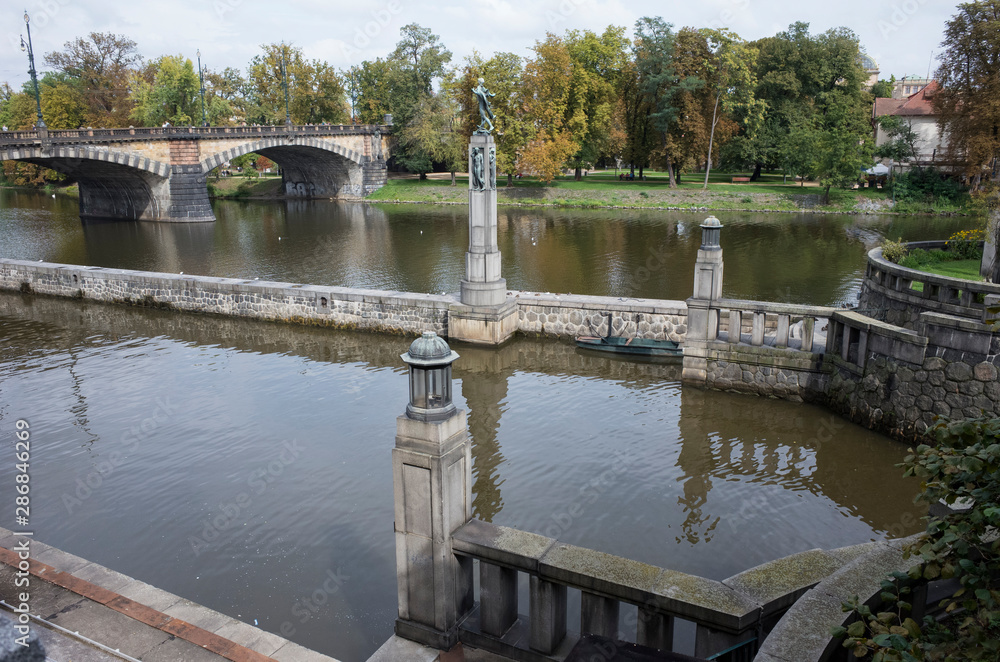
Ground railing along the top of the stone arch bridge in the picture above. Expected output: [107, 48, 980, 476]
[0, 124, 392, 145]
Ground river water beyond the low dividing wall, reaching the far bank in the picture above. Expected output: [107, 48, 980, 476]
[0, 190, 973, 305]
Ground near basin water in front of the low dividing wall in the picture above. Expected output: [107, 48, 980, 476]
[0, 294, 916, 659]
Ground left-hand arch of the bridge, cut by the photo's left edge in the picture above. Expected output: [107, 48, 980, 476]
[0, 145, 171, 221]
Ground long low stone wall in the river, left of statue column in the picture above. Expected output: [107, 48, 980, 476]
[0, 260, 453, 335]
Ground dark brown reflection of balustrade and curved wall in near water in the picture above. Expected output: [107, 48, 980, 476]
[677, 388, 922, 544]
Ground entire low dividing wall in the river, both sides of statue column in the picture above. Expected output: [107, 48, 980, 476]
[0, 259, 687, 342]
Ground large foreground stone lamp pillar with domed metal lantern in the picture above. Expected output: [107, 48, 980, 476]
[392, 331, 473, 650]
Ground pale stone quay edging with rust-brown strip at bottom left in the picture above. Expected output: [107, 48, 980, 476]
[0, 527, 337, 662]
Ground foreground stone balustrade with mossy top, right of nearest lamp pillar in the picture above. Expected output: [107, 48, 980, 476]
[451, 519, 908, 662]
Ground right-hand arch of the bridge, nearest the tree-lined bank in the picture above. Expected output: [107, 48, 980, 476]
[201, 136, 371, 198]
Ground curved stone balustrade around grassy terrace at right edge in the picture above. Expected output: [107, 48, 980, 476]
[860, 241, 1000, 329]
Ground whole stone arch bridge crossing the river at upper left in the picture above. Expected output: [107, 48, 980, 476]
[0, 125, 390, 222]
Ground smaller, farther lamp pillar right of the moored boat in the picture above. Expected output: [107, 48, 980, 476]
[682, 216, 723, 383]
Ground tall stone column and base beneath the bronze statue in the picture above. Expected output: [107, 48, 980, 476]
[448, 132, 517, 345]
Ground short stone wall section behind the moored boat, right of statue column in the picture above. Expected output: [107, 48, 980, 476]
[509, 292, 687, 342]
